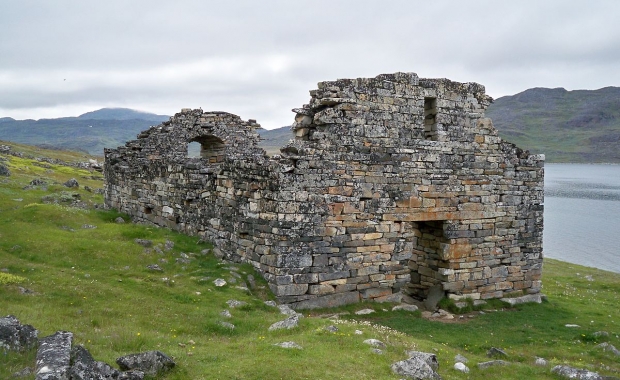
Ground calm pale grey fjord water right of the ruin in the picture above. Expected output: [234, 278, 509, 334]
[543, 164, 620, 273]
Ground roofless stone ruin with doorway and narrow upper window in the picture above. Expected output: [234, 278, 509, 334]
[104, 73, 544, 309]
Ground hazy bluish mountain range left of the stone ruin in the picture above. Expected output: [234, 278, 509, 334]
[0, 108, 169, 156]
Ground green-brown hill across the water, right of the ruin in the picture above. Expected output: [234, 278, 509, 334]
[486, 87, 620, 163]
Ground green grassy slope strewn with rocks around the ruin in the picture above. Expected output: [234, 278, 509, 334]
[0, 144, 620, 379]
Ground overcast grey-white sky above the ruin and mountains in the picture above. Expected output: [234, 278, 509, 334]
[0, 0, 620, 128]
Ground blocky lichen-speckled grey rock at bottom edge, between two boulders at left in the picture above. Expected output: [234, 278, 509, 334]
[35, 331, 73, 380]
